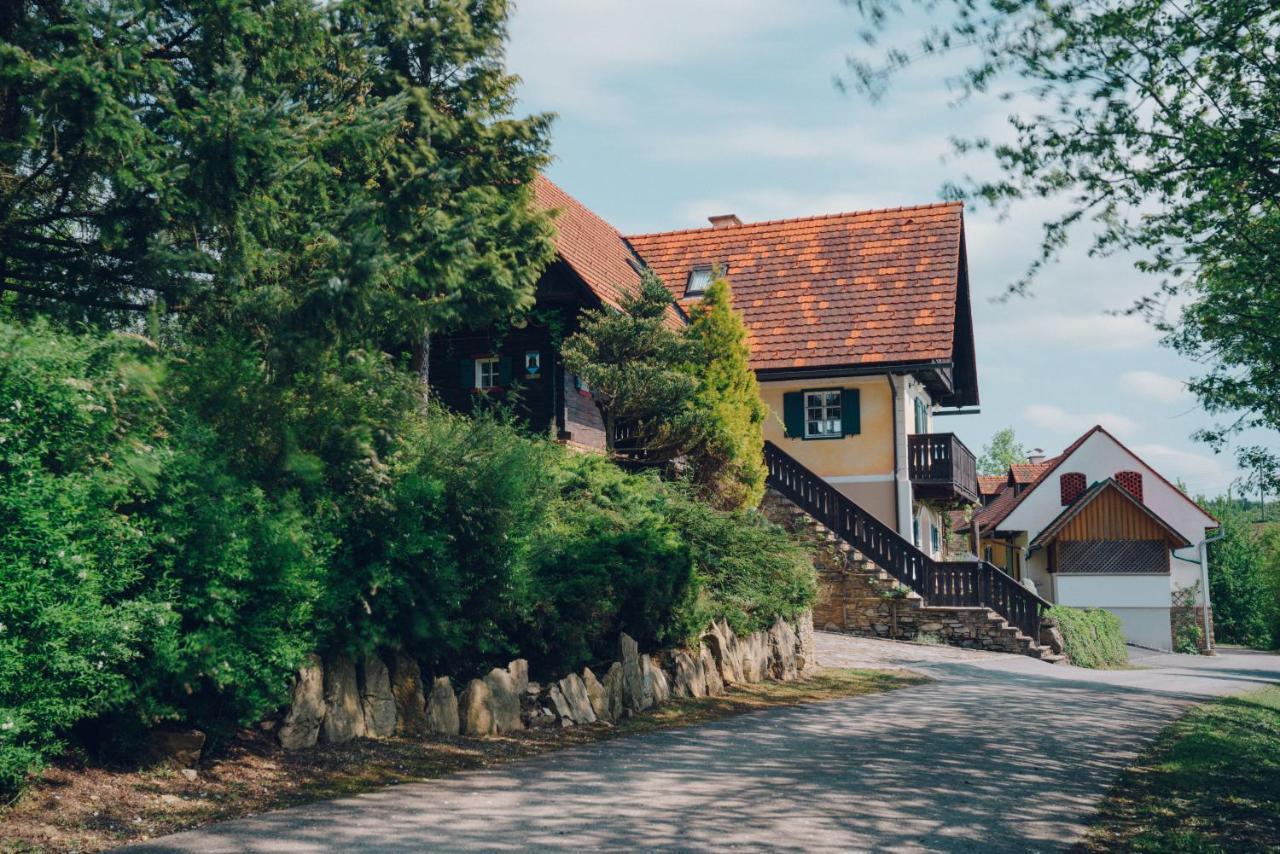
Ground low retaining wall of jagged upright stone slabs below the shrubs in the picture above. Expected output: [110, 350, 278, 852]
[279, 613, 817, 750]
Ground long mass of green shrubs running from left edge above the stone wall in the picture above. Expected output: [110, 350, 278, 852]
[0, 323, 815, 790]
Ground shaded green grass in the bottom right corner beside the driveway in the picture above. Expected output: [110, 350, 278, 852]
[1080, 686, 1280, 851]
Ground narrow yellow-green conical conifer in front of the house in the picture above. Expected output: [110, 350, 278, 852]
[687, 278, 768, 508]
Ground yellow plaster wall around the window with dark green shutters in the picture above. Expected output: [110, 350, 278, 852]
[760, 376, 893, 478]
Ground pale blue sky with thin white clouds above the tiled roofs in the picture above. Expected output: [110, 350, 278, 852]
[508, 0, 1259, 495]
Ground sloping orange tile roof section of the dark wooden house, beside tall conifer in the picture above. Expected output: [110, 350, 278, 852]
[534, 175, 640, 309]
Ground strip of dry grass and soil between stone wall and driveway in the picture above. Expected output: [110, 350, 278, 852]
[0, 668, 927, 854]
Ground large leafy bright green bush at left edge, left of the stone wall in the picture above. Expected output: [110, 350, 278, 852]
[0, 324, 330, 789]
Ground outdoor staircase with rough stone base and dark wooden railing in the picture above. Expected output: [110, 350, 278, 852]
[765, 442, 1062, 662]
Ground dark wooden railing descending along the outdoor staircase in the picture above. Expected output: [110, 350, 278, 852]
[764, 442, 1050, 643]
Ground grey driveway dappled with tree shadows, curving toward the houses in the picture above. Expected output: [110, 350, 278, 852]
[122, 634, 1280, 853]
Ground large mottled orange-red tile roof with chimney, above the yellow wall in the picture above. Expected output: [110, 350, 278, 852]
[627, 202, 964, 370]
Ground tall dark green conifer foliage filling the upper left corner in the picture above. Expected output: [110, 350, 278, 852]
[0, 0, 552, 350]
